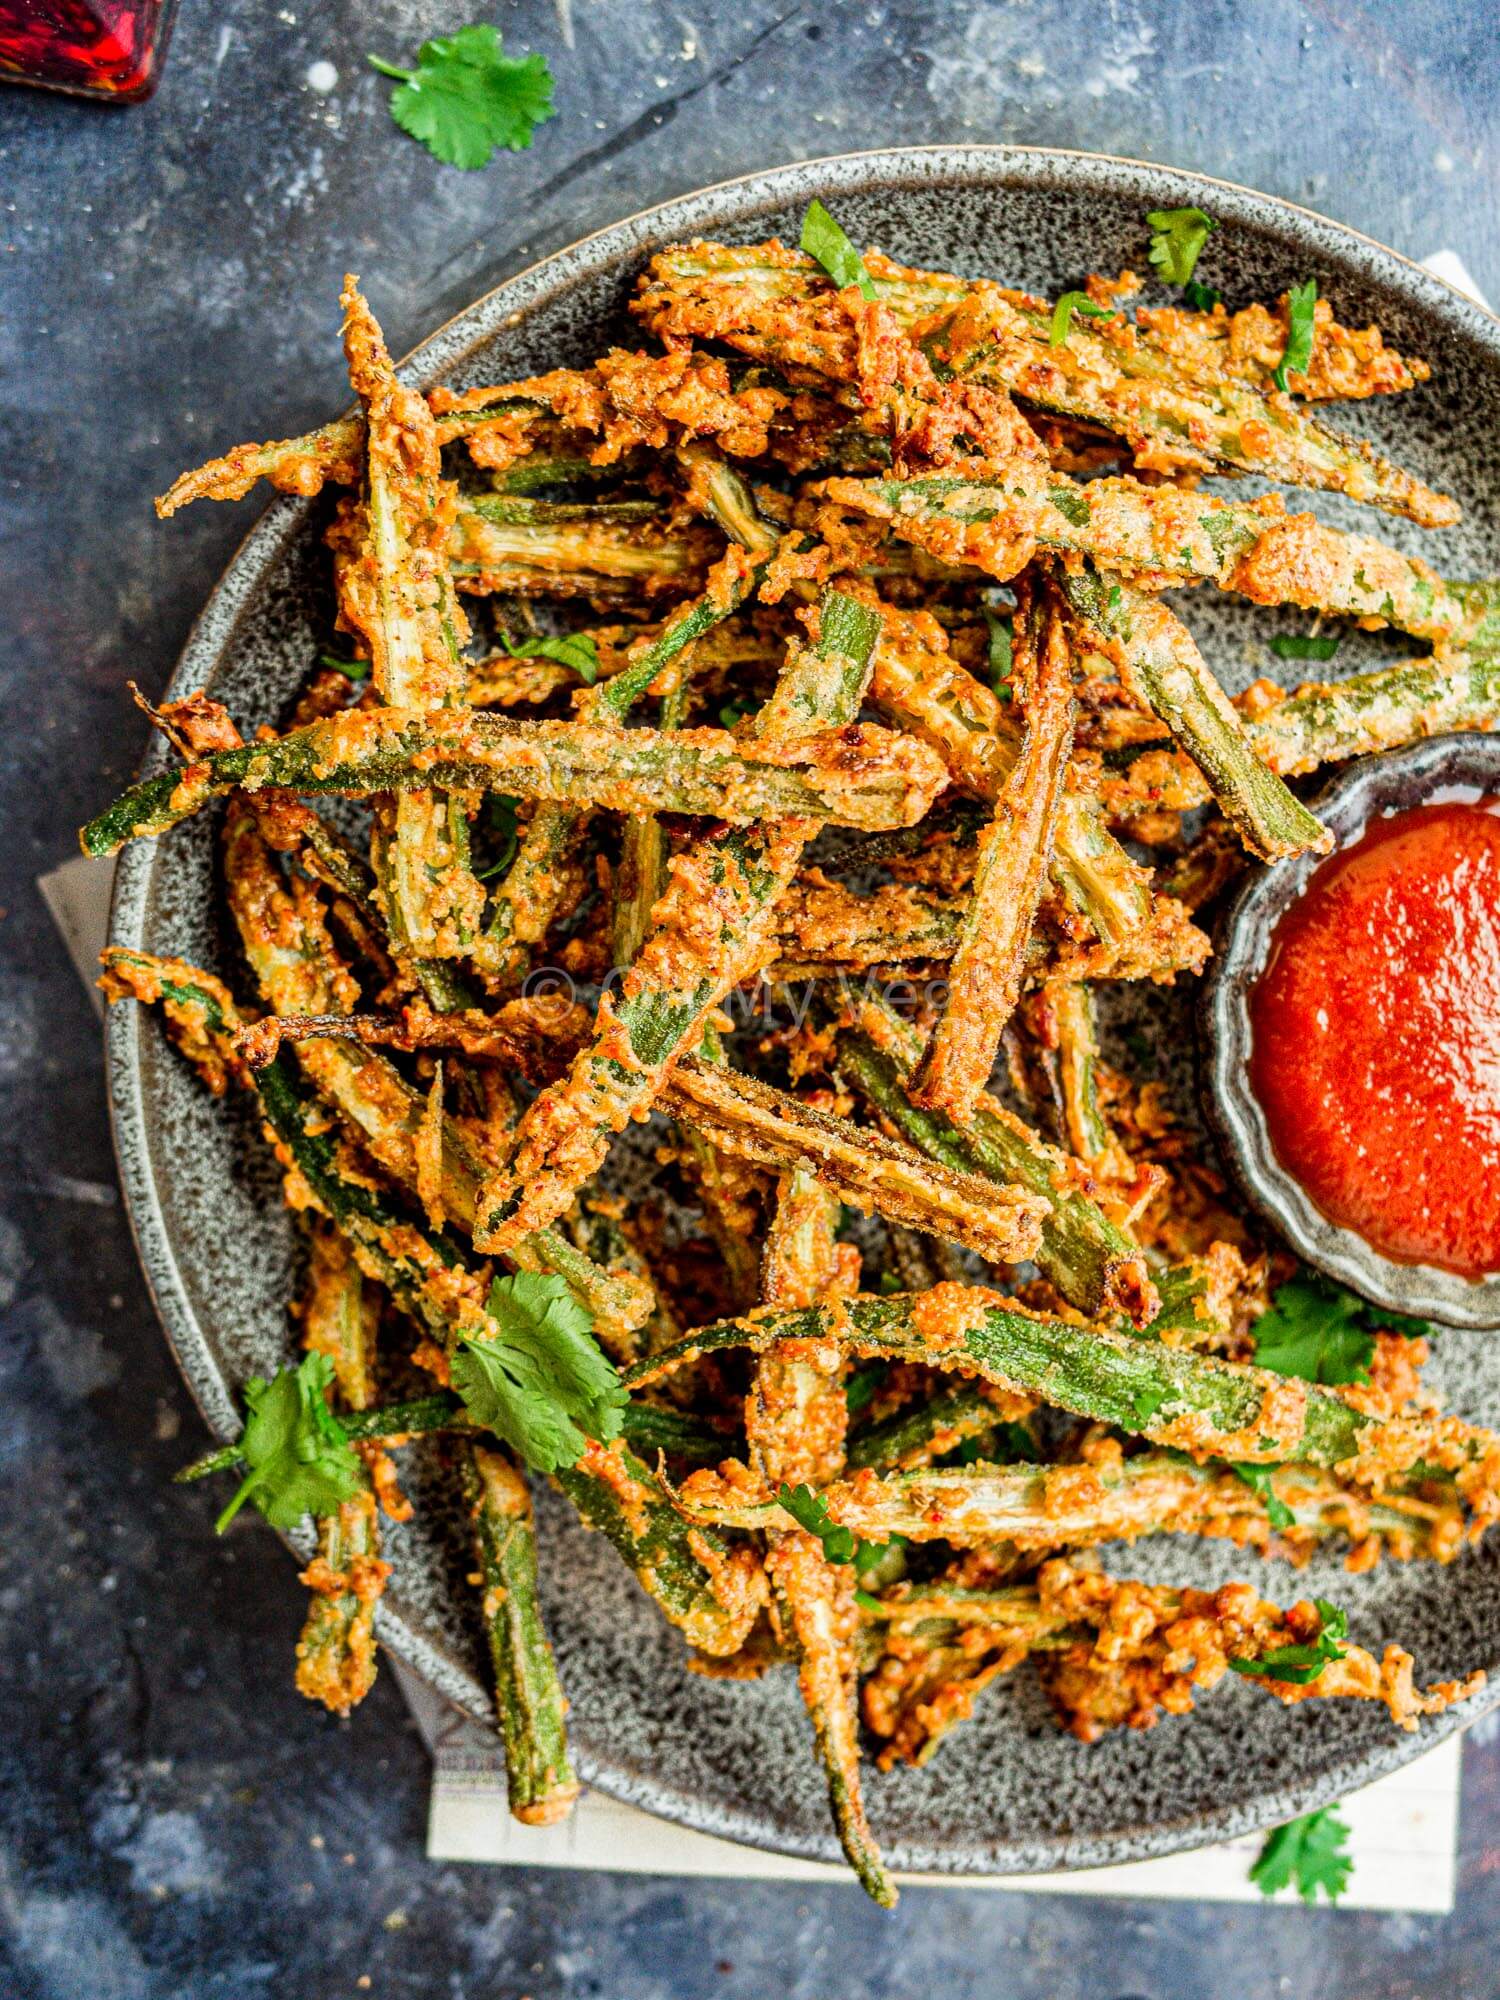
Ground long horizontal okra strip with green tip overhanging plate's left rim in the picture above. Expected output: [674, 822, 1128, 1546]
[80, 708, 946, 856]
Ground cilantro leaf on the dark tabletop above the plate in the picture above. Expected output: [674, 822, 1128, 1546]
[366, 20, 556, 172]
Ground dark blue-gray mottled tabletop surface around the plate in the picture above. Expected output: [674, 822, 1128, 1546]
[0, 0, 1500, 2000]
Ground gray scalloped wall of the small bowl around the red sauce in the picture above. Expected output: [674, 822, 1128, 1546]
[1198, 734, 1500, 1328]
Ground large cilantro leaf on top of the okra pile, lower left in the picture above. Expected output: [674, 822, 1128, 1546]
[452, 1270, 630, 1472]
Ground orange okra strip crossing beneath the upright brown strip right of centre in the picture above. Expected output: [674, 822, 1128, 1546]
[872, 610, 1152, 946]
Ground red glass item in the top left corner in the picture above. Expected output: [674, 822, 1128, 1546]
[0, 0, 176, 104]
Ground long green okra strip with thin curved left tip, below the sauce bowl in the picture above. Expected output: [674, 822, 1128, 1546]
[624, 1284, 1500, 1518]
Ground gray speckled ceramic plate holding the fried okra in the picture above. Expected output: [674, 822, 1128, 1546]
[110, 148, 1500, 1874]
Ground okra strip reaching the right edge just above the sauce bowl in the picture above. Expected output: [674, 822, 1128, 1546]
[1100, 652, 1500, 818]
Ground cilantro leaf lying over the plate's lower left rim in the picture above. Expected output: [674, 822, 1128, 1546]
[214, 1354, 364, 1534]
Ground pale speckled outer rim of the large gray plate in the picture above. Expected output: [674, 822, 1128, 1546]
[106, 144, 1500, 1880]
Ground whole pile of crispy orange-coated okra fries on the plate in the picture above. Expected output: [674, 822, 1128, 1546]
[82, 207, 1500, 1902]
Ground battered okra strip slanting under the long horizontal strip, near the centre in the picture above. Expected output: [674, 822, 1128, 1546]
[476, 590, 888, 1248]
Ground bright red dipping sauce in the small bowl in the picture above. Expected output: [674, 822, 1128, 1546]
[1250, 798, 1500, 1278]
